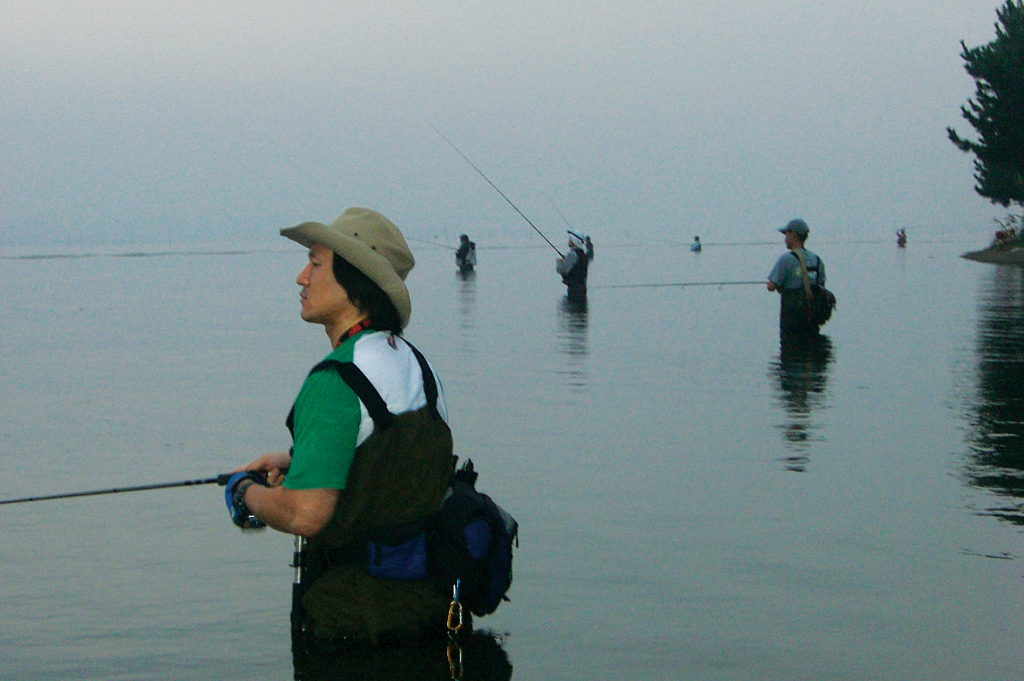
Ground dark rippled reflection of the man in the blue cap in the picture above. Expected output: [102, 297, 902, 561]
[771, 334, 833, 472]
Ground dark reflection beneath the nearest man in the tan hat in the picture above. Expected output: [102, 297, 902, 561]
[292, 631, 512, 681]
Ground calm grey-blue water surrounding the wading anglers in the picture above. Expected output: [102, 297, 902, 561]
[0, 239, 1024, 681]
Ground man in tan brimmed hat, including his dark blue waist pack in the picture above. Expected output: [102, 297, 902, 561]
[225, 208, 516, 643]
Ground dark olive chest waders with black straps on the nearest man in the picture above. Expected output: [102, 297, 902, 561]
[287, 345, 454, 639]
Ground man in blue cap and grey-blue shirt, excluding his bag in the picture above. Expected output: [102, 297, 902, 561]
[768, 218, 825, 334]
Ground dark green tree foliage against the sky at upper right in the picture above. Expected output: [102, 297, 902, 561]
[946, 0, 1024, 206]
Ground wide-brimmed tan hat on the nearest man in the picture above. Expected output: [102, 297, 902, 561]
[281, 208, 416, 329]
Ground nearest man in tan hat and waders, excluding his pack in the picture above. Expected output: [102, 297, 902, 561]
[226, 208, 453, 642]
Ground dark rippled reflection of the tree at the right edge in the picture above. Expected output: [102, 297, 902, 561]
[966, 266, 1024, 524]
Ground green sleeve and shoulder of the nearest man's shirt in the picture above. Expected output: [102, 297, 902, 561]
[285, 331, 372, 490]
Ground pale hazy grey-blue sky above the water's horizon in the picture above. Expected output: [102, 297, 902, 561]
[0, 0, 1007, 248]
